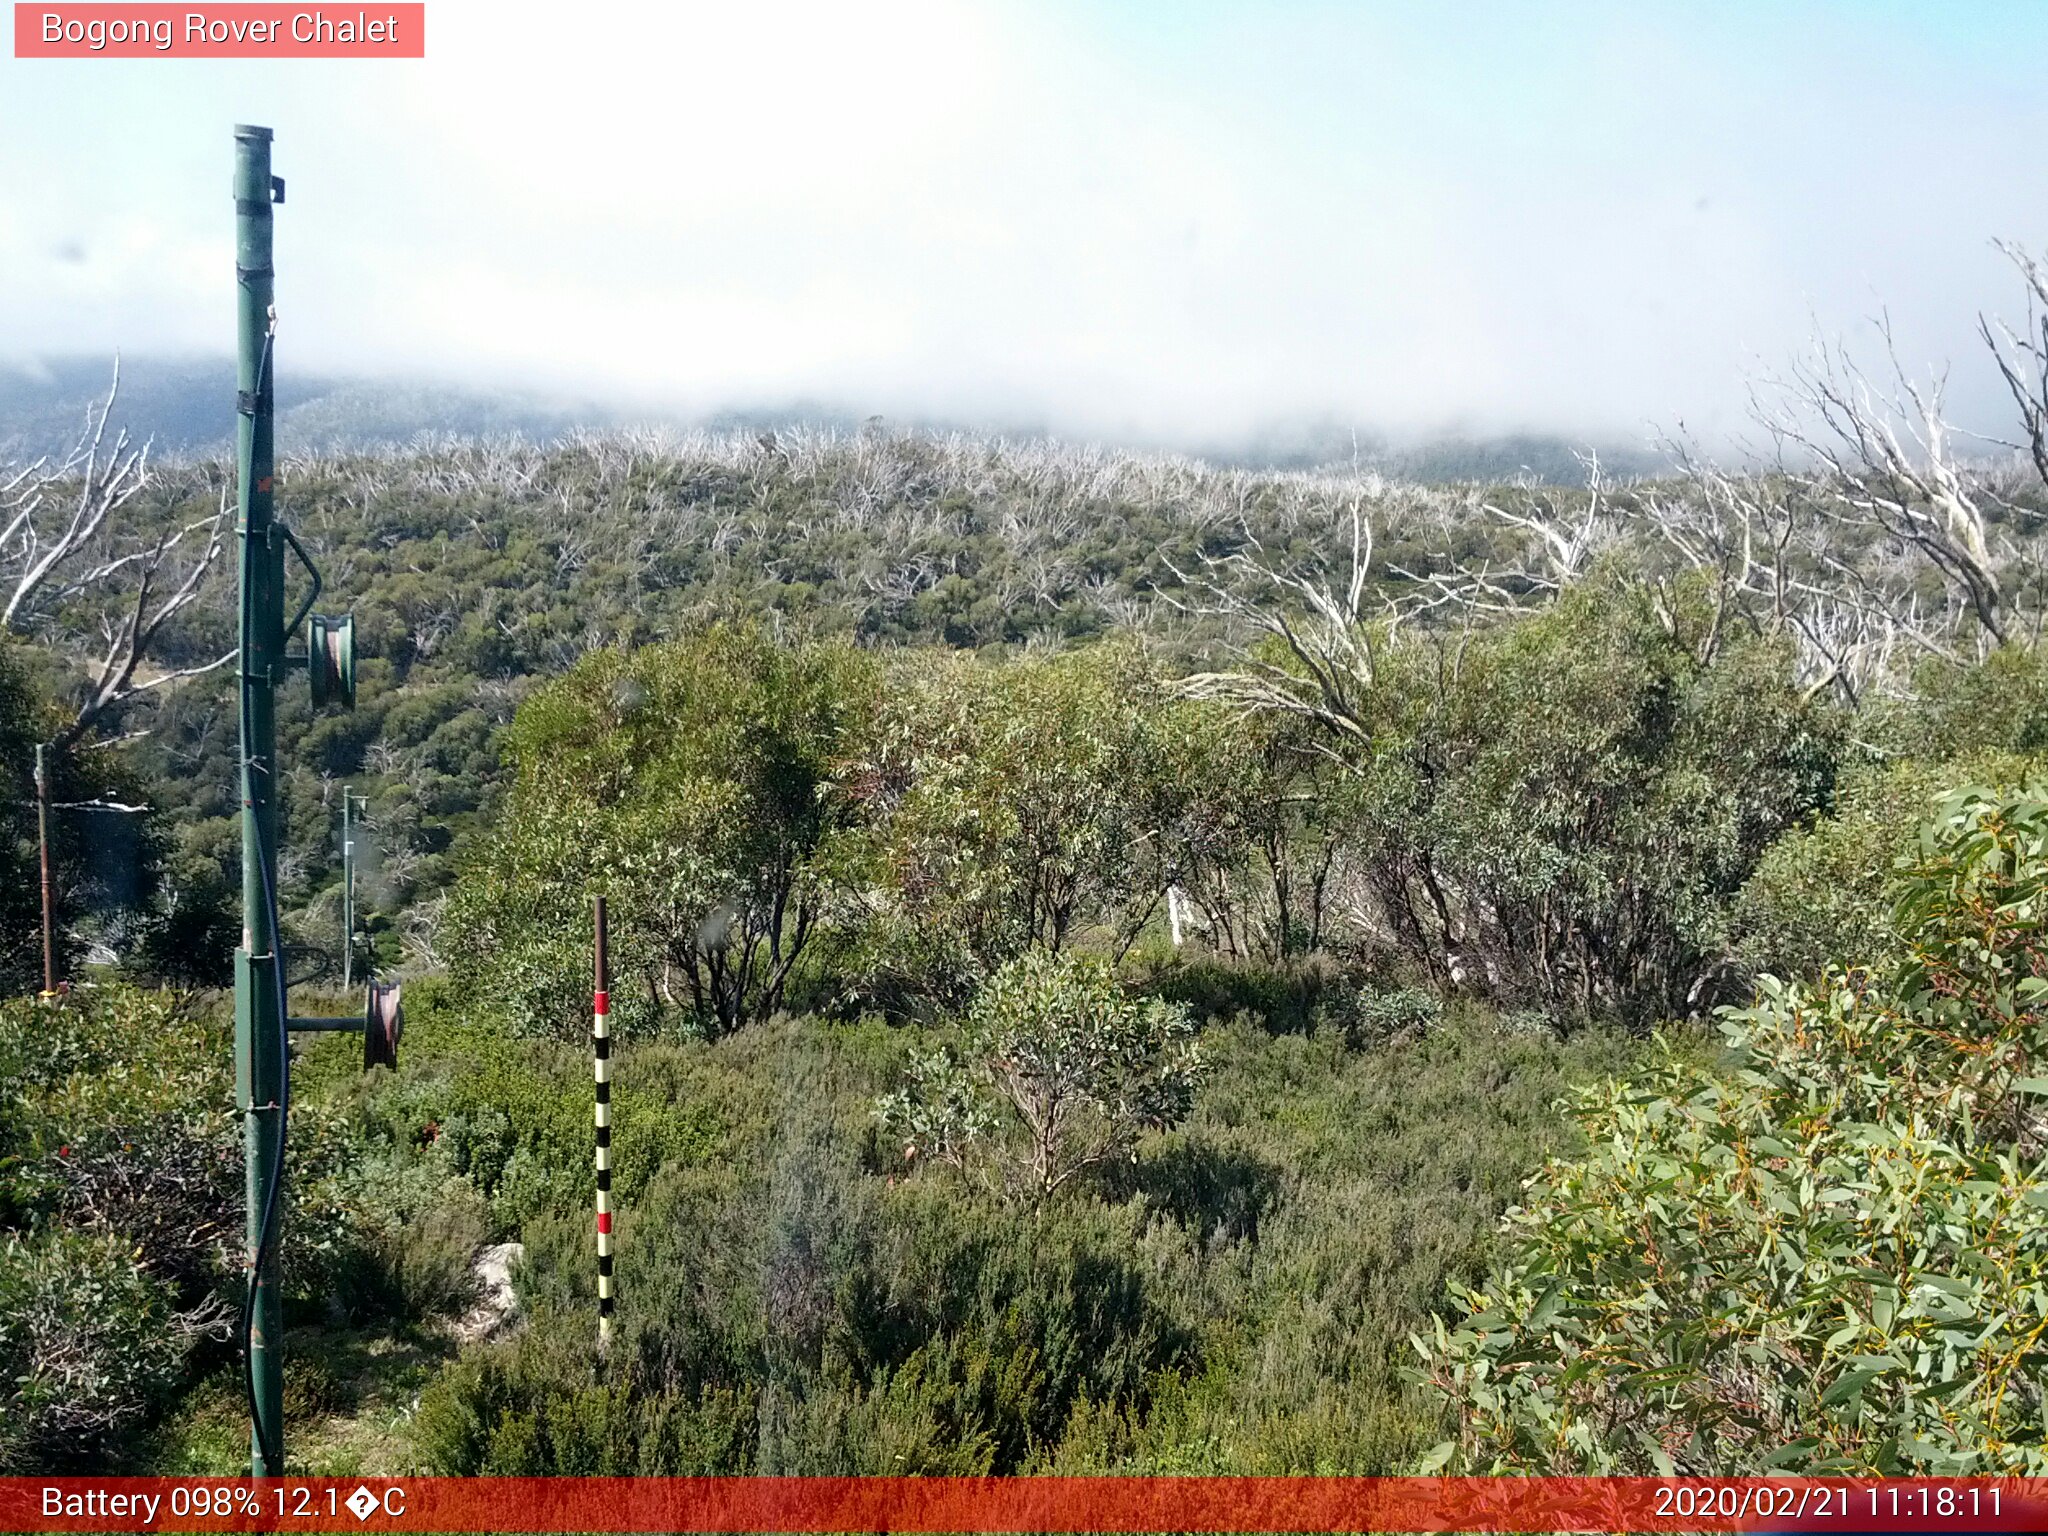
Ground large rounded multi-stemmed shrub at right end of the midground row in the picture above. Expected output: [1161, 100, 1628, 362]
[1236, 569, 1841, 1026]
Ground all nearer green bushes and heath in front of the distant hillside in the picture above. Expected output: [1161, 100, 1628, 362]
[19, 536, 2034, 1473]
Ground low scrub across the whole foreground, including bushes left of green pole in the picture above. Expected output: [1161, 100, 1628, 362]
[0, 958, 1632, 1473]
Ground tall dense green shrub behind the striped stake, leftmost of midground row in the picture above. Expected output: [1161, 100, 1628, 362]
[449, 627, 872, 1040]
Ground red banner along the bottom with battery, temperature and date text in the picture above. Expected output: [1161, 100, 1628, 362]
[12, 1477, 2048, 1536]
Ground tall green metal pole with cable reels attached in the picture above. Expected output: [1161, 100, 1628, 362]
[236, 127, 285, 1477]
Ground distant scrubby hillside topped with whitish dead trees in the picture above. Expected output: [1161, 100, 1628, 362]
[19, 432, 1712, 987]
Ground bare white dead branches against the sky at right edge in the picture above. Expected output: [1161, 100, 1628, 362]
[1638, 253, 2048, 709]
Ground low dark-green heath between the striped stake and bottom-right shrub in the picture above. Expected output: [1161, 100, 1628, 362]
[414, 1010, 1628, 1473]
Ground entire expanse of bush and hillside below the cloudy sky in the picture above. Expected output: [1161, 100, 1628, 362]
[12, 288, 2048, 1473]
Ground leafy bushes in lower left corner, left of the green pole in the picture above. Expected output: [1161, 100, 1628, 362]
[0, 987, 242, 1473]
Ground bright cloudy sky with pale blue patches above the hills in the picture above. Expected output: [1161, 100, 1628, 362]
[0, 0, 2048, 444]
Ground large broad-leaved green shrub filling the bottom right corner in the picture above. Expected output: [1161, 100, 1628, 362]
[1415, 782, 2048, 1477]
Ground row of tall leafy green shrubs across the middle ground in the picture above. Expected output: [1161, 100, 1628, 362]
[451, 578, 1843, 1038]
